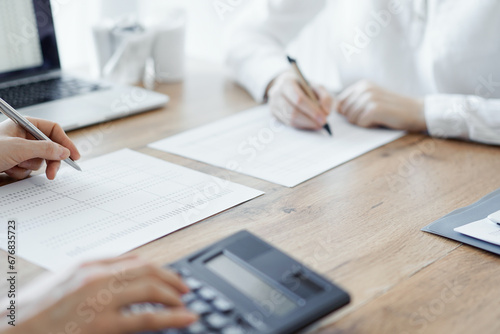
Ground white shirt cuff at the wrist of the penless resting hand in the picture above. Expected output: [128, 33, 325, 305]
[424, 95, 470, 139]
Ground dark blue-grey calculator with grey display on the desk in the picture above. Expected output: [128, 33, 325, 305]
[143, 231, 350, 334]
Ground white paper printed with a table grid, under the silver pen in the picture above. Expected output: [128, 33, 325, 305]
[0, 150, 263, 271]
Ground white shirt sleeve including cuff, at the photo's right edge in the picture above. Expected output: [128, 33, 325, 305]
[425, 95, 500, 145]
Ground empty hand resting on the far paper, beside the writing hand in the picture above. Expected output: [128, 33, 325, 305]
[335, 80, 427, 132]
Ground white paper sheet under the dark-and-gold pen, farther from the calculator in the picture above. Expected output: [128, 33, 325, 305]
[149, 106, 404, 187]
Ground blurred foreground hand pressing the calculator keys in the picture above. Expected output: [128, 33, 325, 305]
[2, 256, 198, 334]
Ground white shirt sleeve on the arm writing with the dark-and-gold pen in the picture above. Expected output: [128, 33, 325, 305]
[227, 0, 325, 102]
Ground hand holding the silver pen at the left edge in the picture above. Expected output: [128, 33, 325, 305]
[0, 118, 80, 180]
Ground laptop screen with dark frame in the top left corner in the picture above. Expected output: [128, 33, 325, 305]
[0, 0, 60, 81]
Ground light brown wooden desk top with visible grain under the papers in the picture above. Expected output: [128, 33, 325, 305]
[0, 63, 500, 333]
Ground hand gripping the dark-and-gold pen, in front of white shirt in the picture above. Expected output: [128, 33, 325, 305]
[267, 71, 333, 130]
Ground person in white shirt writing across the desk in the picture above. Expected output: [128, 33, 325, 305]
[227, 0, 500, 144]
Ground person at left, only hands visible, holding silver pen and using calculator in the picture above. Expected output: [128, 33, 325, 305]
[0, 118, 197, 334]
